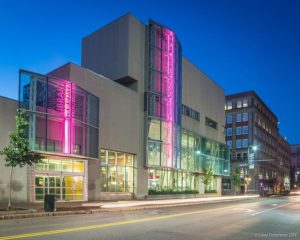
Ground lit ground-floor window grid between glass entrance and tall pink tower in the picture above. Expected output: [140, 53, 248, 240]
[101, 149, 136, 193]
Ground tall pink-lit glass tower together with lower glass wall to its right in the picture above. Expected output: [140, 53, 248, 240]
[146, 21, 230, 192]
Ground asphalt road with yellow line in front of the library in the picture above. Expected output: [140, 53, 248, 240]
[0, 196, 300, 240]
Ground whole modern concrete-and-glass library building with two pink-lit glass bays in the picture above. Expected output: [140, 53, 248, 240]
[0, 14, 230, 202]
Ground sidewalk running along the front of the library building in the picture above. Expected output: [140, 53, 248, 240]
[0, 195, 259, 220]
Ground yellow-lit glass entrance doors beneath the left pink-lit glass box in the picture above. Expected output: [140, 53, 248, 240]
[34, 158, 86, 201]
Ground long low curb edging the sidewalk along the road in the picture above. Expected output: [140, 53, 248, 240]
[0, 198, 253, 220]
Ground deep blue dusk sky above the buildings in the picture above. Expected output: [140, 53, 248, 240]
[0, 0, 300, 143]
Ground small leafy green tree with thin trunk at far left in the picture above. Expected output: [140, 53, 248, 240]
[0, 110, 42, 210]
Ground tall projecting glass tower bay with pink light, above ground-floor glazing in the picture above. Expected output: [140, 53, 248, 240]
[146, 22, 181, 168]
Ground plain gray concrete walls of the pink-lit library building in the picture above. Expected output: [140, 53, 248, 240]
[0, 14, 225, 201]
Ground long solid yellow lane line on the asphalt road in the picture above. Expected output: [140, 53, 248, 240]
[0, 202, 256, 240]
